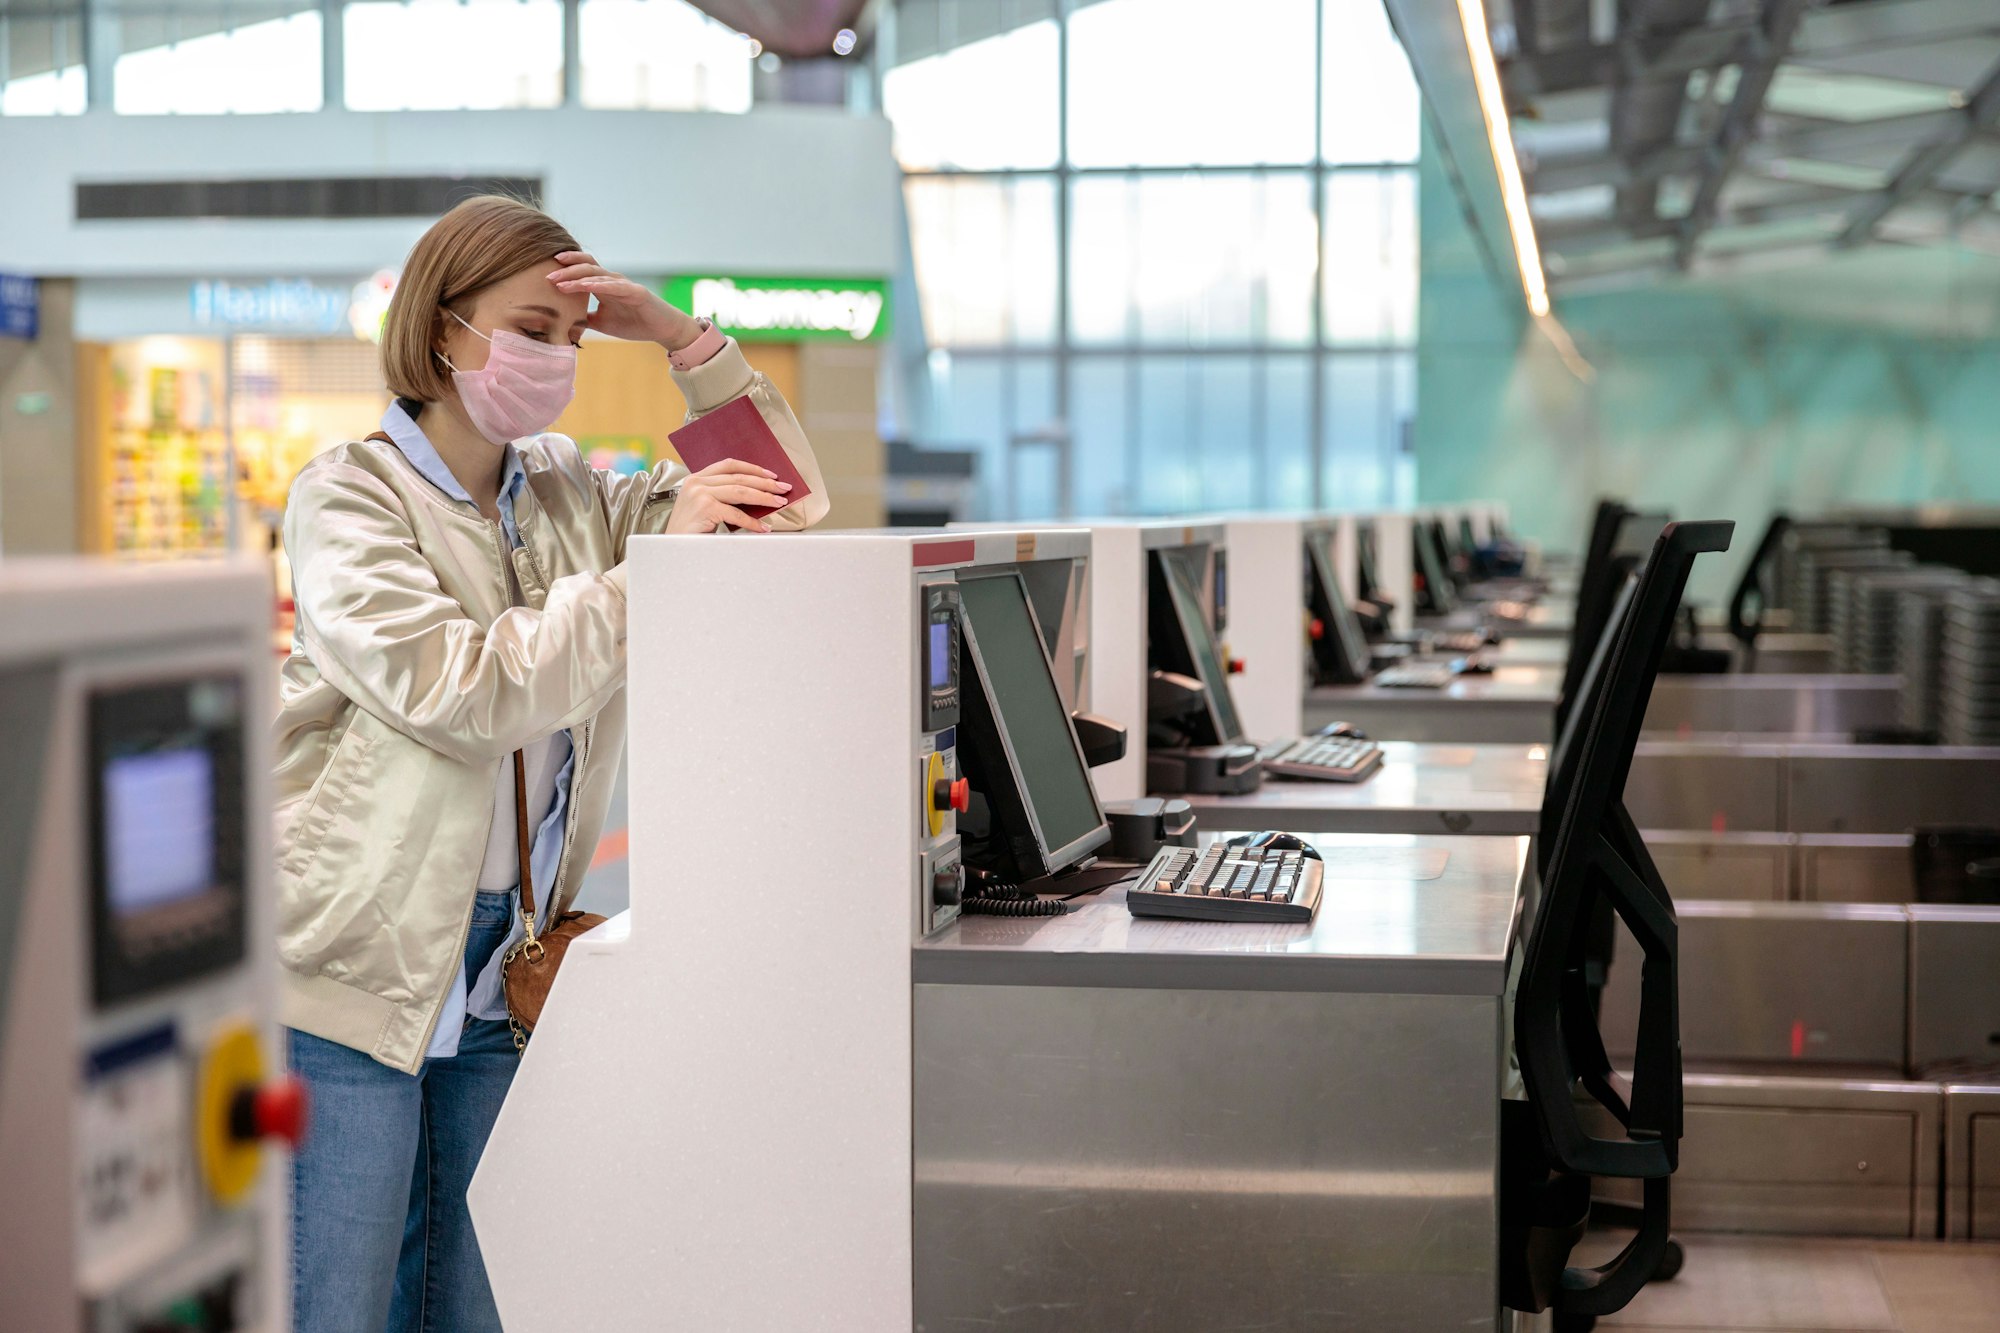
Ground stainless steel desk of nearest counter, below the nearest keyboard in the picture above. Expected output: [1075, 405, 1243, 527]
[912, 837, 1528, 1333]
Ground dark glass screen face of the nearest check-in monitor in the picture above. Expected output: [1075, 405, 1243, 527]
[958, 572, 1104, 869]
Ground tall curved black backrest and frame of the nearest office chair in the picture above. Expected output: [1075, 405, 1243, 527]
[1514, 522, 1736, 1313]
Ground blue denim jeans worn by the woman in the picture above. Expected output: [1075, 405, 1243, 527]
[286, 893, 520, 1333]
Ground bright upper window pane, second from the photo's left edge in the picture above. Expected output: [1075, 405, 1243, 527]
[112, 0, 326, 116]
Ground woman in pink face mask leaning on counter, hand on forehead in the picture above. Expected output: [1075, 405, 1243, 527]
[276, 198, 826, 1333]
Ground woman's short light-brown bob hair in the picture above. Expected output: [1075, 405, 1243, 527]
[382, 194, 582, 402]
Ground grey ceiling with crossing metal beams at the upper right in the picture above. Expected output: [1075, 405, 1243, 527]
[1496, 0, 2000, 296]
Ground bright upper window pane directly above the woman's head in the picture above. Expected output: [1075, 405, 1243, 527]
[342, 0, 562, 110]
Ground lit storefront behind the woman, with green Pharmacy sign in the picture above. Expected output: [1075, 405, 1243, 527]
[76, 272, 888, 564]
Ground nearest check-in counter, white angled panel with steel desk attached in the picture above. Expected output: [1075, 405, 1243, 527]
[468, 532, 1532, 1333]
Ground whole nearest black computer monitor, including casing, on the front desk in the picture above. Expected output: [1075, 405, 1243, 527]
[958, 570, 1110, 883]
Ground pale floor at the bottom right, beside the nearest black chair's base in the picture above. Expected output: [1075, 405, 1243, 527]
[1588, 1235, 2000, 1333]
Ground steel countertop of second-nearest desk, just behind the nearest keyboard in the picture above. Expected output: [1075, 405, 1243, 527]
[1186, 741, 1548, 835]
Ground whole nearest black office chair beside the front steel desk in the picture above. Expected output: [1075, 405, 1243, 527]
[1500, 522, 1734, 1333]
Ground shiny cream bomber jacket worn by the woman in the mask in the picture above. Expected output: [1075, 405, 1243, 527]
[274, 338, 826, 1073]
